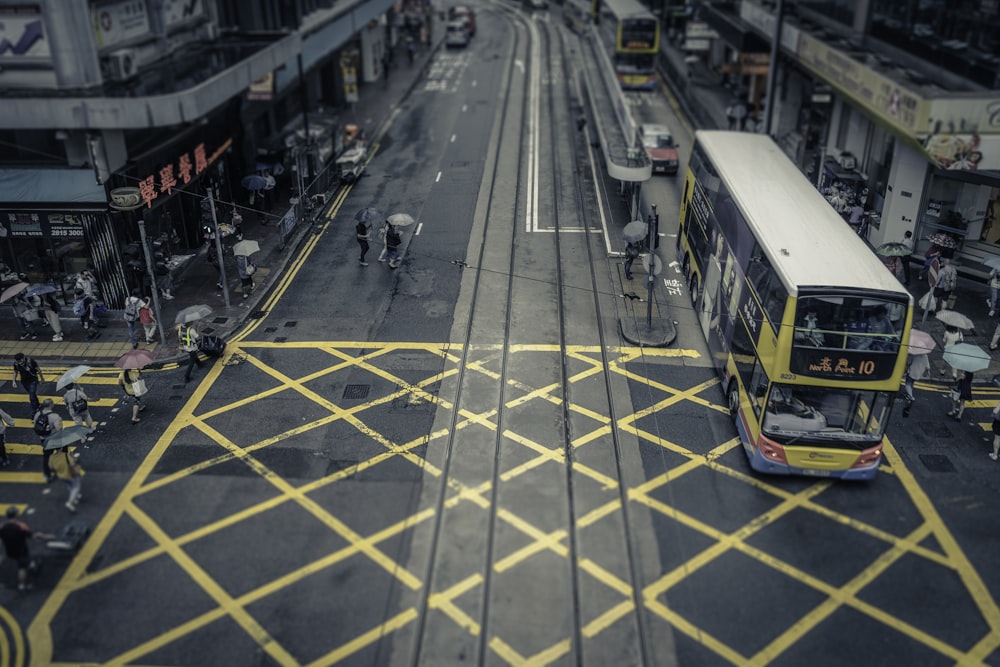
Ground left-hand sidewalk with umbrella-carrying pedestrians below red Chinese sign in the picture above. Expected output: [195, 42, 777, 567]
[0, 43, 439, 368]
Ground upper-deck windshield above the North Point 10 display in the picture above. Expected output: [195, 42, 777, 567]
[794, 295, 906, 353]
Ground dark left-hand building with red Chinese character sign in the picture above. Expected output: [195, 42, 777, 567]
[0, 0, 405, 307]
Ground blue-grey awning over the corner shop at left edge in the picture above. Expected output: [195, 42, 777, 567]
[0, 169, 108, 208]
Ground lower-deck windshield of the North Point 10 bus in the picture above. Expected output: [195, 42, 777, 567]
[762, 384, 889, 448]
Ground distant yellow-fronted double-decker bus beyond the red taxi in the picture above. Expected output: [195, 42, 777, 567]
[598, 0, 660, 90]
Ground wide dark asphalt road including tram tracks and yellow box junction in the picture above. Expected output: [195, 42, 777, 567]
[2, 6, 1000, 665]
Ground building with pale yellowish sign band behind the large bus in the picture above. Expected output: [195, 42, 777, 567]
[698, 0, 1000, 274]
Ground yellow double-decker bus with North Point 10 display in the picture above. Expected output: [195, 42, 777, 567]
[677, 131, 913, 479]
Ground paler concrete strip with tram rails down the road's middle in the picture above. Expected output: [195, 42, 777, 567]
[407, 10, 651, 665]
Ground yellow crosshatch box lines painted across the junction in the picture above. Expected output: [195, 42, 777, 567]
[21, 340, 1000, 665]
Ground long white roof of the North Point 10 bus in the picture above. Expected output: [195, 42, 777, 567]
[695, 131, 906, 294]
